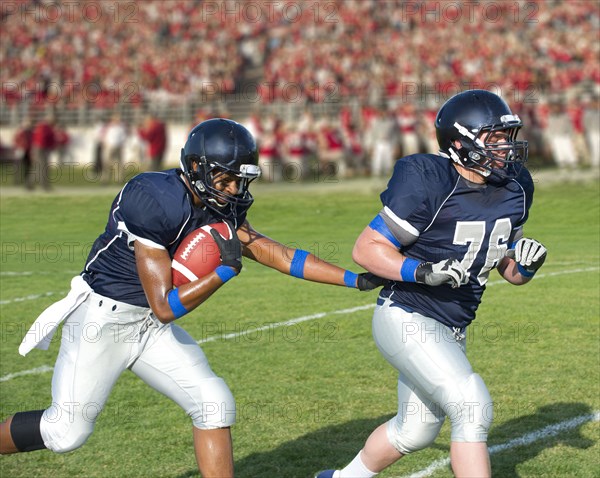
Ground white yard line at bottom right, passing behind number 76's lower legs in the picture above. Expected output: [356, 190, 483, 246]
[405, 410, 600, 478]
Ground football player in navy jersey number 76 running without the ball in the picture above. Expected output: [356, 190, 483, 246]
[317, 90, 546, 478]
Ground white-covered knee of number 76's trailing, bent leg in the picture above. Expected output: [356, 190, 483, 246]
[386, 411, 444, 455]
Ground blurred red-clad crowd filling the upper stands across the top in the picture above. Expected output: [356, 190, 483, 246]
[0, 0, 600, 106]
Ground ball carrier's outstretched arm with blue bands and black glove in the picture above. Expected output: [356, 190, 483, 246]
[237, 221, 385, 290]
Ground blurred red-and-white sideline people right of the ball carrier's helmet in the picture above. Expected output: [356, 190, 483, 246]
[237, 97, 600, 181]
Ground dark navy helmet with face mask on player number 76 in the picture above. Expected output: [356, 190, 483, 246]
[435, 90, 528, 181]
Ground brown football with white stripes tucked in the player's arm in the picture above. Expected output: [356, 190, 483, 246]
[171, 222, 231, 287]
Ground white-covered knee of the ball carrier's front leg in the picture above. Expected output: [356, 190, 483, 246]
[186, 377, 236, 429]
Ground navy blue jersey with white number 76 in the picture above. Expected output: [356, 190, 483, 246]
[380, 154, 533, 329]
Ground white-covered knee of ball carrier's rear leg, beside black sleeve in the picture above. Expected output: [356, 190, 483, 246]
[40, 404, 98, 453]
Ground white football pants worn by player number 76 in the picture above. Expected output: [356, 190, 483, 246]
[373, 299, 493, 454]
